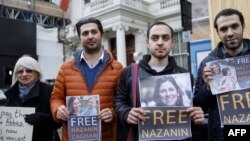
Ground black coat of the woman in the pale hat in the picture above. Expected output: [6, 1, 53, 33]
[5, 81, 60, 141]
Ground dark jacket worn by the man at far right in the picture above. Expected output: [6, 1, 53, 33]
[193, 39, 250, 141]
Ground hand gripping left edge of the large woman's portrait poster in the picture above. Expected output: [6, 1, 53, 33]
[127, 108, 146, 124]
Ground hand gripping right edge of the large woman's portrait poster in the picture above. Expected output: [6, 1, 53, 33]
[187, 107, 205, 124]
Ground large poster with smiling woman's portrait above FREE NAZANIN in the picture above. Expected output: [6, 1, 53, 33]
[138, 73, 192, 140]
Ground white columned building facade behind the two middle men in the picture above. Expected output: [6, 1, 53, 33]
[65, 0, 189, 68]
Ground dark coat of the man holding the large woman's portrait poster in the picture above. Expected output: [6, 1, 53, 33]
[115, 55, 193, 141]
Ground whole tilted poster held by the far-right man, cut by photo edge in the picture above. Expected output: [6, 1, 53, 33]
[206, 55, 250, 126]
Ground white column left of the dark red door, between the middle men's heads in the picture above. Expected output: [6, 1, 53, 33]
[112, 24, 128, 67]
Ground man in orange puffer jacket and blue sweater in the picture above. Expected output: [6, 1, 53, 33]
[50, 18, 123, 141]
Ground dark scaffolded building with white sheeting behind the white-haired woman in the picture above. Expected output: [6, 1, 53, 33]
[0, 0, 70, 89]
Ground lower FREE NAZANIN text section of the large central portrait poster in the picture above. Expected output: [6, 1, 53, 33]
[139, 107, 192, 140]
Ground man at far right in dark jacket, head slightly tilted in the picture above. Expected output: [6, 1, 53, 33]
[194, 9, 250, 141]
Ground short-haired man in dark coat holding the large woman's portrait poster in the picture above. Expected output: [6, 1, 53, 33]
[115, 22, 204, 141]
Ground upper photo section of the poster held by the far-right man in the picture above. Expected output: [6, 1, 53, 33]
[206, 55, 250, 95]
